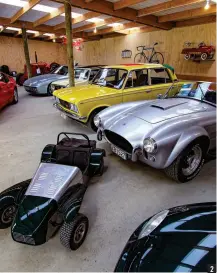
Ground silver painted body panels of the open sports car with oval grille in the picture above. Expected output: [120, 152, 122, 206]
[98, 94, 216, 169]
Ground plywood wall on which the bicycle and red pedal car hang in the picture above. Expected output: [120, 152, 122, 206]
[75, 23, 216, 77]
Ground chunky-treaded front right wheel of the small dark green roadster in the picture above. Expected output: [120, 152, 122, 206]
[60, 214, 89, 250]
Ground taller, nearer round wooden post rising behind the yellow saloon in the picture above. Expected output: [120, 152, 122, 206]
[64, 2, 75, 87]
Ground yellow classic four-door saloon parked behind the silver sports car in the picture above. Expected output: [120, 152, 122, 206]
[53, 63, 186, 131]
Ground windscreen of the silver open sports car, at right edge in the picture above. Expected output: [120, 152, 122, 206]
[168, 82, 216, 104]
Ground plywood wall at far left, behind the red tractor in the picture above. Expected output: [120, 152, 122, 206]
[0, 36, 67, 72]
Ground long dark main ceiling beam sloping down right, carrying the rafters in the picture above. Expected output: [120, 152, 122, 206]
[52, 0, 173, 30]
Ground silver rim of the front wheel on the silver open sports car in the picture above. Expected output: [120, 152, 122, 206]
[182, 145, 203, 176]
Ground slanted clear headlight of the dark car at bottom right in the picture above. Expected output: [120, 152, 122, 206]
[138, 210, 169, 239]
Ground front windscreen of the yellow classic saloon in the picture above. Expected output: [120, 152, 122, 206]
[92, 68, 127, 89]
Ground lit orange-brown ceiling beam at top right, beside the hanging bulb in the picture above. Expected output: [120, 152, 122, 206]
[158, 5, 216, 22]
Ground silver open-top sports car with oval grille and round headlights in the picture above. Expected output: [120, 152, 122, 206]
[94, 82, 216, 183]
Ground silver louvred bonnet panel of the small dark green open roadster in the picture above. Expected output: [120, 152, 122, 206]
[25, 163, 83, 202]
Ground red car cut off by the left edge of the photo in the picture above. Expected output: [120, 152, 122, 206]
[0, 72, 18, 109]
